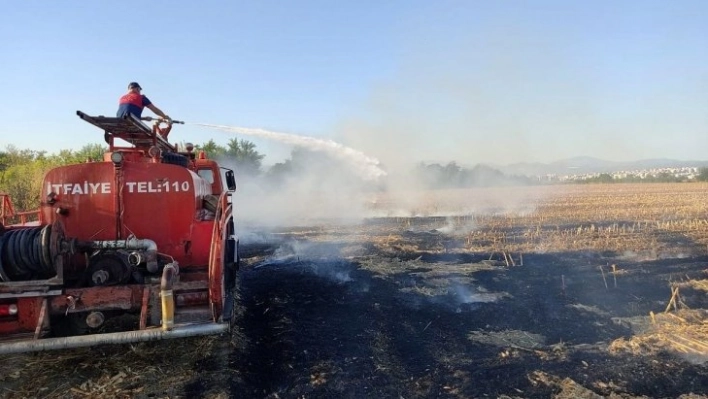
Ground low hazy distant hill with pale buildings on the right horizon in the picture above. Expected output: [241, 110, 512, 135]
[489, 157, 708, 176]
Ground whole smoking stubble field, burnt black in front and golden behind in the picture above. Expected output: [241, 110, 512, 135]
[0, 184, 708, 398]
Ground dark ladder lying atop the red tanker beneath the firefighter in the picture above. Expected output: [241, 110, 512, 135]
[76, 111, 177, 152]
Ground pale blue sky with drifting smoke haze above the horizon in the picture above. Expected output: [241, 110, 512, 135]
[0, 0, 708, 164]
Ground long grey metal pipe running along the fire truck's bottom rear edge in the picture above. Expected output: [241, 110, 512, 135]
[0, 323, 229, 355]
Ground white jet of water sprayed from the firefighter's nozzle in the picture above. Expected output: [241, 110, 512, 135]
[193, 123, 386, 180]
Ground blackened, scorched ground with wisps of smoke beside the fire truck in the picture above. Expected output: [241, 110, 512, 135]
[230, 232, 708, 398]
